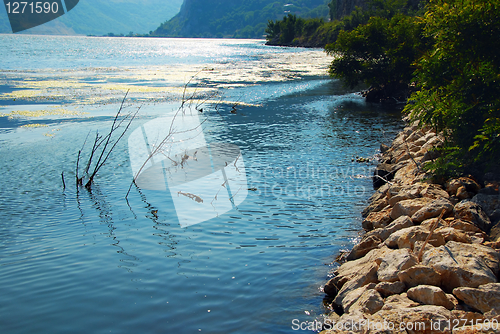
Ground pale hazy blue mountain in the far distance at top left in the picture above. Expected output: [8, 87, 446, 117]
[0, 0, 182, 35]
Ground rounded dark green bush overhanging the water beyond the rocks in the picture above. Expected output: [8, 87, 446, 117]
[326, 14, 427, 88]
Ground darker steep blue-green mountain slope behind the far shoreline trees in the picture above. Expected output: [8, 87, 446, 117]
[153, 0, 330, 38]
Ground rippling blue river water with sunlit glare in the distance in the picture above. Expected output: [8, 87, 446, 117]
[0, 35, 400, 333]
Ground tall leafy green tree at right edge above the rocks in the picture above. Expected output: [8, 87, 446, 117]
[405, 0, 500, 175]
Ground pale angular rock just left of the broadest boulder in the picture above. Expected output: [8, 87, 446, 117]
[377, 248, 418, 282]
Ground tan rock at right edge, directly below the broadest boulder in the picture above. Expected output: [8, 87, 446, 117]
[453, 283, 500, 313]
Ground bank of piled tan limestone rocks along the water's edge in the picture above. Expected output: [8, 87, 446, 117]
[322, 121, 500, 334]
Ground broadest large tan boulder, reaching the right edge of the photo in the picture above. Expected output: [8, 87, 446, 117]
[422, 241, 500, 292]
